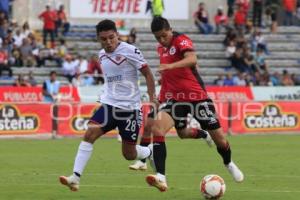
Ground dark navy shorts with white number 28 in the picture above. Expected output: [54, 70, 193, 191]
[90, 104, 142, 144]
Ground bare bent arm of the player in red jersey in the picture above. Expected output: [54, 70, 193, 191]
[158, 51, 197, 71]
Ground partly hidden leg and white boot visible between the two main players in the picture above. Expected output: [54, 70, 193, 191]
[129, 115, 154, 170]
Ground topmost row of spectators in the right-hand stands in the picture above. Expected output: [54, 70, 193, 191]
[193, 0, 300, 34]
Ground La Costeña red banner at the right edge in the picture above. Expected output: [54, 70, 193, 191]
[232, 102, 300, 134]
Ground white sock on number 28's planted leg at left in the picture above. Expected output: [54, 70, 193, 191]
[73, 141, 93, 175]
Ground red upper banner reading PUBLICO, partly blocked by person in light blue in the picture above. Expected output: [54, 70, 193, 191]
[0, 86, 80, 103]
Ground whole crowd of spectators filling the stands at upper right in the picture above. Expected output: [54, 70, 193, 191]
[193, 0, 300, 86]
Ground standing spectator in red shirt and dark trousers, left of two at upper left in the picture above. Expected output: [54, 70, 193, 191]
[39, 4, 57, 48]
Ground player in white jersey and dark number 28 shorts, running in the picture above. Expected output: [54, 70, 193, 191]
[59, 19, 156, 191]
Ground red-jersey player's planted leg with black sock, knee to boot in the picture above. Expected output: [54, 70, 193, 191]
[146, 111, 174, 192]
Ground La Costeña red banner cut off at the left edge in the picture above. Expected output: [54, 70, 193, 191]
[0, 104, 53, 135]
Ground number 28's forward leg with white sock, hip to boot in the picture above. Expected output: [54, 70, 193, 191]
[59, 105, 113, 191]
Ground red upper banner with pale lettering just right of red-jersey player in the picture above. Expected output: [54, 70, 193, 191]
[206, 86, 253, 102]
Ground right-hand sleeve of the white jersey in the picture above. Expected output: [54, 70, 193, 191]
[126, 47, 148, 69]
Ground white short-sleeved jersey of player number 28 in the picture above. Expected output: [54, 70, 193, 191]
[99, 42, 147, 110]
